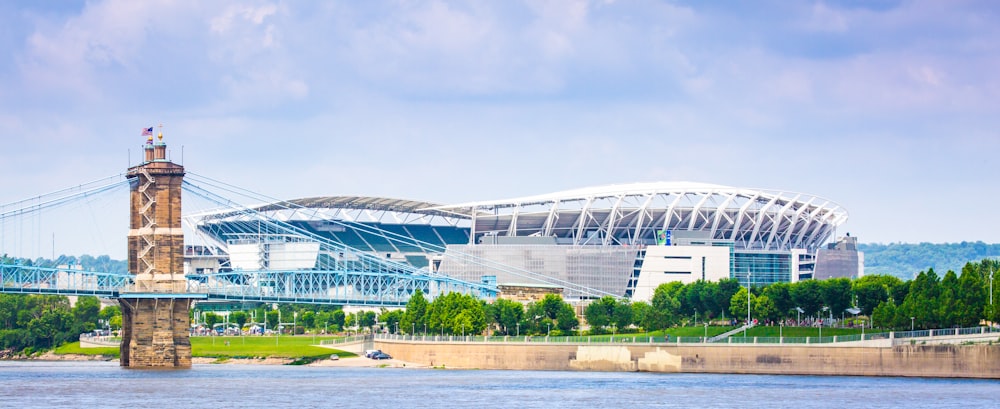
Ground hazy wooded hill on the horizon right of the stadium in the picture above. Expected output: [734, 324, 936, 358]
[858, 241, 1000, 280]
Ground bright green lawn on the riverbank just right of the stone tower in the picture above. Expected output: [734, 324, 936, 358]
[191, 335, 356, 360]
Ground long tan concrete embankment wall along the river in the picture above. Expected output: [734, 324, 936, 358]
[375, 340, 1000, 379]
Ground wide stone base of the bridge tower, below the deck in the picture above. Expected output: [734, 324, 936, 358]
[119, 296, 191, 368]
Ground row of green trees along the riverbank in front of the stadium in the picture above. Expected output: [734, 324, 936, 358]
[0, 259, 1000, 353]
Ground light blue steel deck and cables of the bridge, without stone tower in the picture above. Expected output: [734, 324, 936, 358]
[0, 172, 607, 307]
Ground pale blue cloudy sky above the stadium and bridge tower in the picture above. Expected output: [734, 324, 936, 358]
[0, 0, 1000, 253]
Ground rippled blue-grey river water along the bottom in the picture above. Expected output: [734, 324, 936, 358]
[0, 361, 1000, 409]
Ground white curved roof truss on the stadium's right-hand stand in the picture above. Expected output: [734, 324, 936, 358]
[427, 182, 848, 250]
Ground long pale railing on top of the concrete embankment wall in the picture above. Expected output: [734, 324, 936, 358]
[374, 327, 1000, 345]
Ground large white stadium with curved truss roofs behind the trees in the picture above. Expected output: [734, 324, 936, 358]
[188, 182, 863, 300]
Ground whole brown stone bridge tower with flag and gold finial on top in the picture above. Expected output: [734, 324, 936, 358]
[119, 131, 191, 368]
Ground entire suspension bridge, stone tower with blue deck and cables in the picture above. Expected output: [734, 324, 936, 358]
[0, 133, 516, 368]
